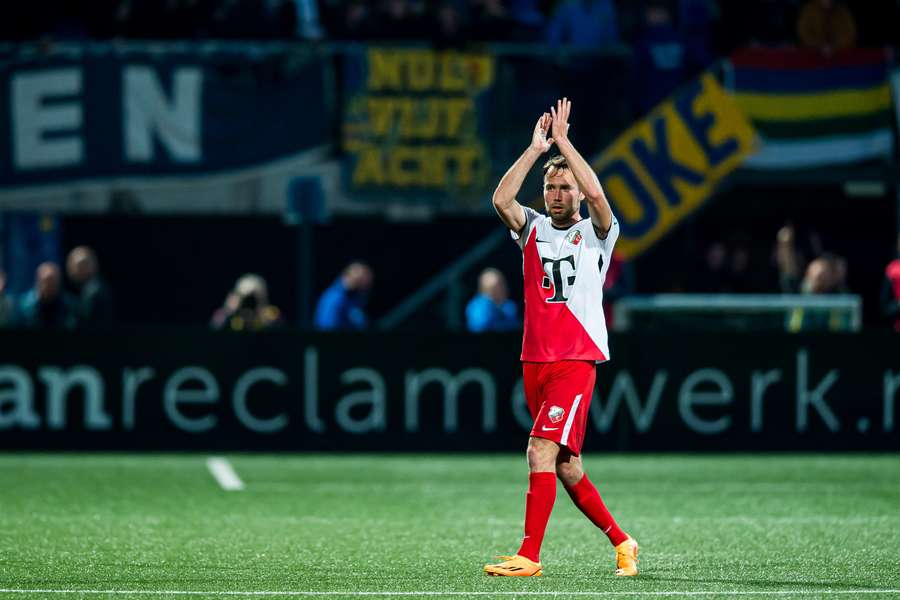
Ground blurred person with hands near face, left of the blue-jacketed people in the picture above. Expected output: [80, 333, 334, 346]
[210, 273, 282, 331]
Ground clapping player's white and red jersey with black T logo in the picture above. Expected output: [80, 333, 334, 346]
[510, 207, 619, 362]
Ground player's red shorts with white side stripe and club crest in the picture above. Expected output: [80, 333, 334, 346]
[522, 360, 597, 456]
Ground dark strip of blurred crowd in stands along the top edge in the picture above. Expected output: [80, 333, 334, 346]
[0, 0, 898, 49]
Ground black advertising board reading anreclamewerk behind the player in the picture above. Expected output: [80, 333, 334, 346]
[0, 330, 900, 451]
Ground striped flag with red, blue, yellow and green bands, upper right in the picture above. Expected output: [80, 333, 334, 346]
[725, 48, 894, 169]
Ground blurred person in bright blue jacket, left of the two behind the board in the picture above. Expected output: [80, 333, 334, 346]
[314, 262, 373, 331]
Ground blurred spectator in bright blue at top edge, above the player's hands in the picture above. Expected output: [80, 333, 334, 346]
[547, 0, 619, 48]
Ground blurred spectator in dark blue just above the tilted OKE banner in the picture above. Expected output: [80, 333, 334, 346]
[632, 2, 689, 114]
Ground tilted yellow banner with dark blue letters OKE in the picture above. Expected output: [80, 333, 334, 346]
[593, 73, 756, 260]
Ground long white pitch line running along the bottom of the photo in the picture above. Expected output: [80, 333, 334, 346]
[0, 589, 900, 598]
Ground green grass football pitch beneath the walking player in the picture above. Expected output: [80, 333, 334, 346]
[0, 454, 900, 600]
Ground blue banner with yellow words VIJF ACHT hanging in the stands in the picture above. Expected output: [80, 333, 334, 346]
[343, 48, 494, 192]
